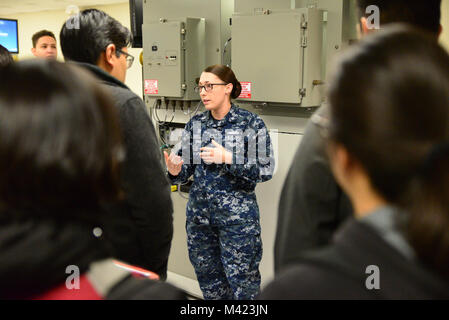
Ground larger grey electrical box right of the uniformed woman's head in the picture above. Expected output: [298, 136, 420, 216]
[232, 8, 323, 107]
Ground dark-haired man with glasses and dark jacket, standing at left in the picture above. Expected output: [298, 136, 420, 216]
[60, 9, 173, 278]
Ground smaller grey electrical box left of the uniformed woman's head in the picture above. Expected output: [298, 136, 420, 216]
[142, 18, 205, 100]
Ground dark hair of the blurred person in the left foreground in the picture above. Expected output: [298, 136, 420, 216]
[0, 60, 123, 220]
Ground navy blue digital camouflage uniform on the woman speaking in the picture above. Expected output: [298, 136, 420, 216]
[169, 104, 274, 300]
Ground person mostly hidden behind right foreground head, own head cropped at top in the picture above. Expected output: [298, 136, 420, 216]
[274, 0, 441, 272]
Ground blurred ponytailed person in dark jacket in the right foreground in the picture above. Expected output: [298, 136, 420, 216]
[260, 27, 449, 299]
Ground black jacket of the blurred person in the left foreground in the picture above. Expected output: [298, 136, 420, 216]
[0, 210, 186, 299]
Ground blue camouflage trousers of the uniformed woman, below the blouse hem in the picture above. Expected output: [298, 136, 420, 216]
[186, 221, 262, 300]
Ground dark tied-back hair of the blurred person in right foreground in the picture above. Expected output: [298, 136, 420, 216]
[329, 26, 449, 278]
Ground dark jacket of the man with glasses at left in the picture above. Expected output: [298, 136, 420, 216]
[77, 63, 173, 278]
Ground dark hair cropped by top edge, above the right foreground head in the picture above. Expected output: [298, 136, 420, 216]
[357, 0, 441, 35]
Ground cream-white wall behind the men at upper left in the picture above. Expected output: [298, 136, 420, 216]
[2, 2, 142, 97]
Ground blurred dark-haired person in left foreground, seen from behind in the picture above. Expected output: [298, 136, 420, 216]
[0, 61, 185, 300]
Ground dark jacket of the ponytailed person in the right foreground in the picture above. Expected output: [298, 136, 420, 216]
[259, 219, 449, 300]
